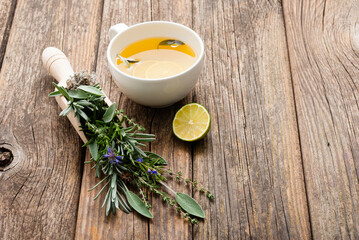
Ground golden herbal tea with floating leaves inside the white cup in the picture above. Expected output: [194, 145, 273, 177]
[116, 37, 198, 79]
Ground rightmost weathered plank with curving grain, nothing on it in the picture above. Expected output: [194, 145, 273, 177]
[283, 0, 359, 239]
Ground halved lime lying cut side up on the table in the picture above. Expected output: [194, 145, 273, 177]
[172, 103, 211, 142]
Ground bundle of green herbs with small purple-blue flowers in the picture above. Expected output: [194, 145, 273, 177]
[49, 72, 214, 224]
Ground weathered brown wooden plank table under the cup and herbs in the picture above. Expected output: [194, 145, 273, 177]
[0, 0, 359, 239]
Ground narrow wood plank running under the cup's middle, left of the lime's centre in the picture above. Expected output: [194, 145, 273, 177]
[149, 0, 193, 240]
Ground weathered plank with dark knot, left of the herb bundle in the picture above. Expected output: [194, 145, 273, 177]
[0, 1, 101, 239]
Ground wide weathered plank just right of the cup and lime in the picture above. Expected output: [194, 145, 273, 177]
[193, 1, 311, 239]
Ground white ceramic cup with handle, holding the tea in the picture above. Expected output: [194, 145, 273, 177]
[107, 21, 204, 107]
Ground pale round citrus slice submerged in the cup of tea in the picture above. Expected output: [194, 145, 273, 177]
[146, 61, 183, 79]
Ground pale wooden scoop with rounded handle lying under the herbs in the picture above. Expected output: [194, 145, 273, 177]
[42, 47, 112, 143]
